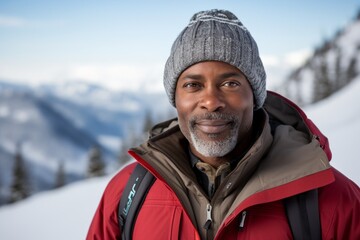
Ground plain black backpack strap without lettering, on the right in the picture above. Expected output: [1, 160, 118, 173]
[284, 189, 321, 240]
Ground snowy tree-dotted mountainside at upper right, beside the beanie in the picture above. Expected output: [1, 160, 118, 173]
[279, 14, 360, 105]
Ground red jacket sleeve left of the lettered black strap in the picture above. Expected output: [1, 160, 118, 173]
[86, 163, 135, 240]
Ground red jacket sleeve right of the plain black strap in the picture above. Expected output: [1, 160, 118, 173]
[320, 169, 360, 239]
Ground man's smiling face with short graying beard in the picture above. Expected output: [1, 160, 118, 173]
[175, 61, 254, 158]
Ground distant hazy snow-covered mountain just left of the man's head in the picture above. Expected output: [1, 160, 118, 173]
[37, 81, 171, 144]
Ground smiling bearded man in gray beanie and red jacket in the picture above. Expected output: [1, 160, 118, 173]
[87, 10, 360, 239]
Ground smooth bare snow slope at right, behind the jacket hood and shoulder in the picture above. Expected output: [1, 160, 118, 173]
[306, 76, 360, 184]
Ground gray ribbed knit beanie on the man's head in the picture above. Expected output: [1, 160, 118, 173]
[164, 9, 266, 109]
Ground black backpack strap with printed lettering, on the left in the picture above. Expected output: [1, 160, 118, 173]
[118, 164, 155, 240]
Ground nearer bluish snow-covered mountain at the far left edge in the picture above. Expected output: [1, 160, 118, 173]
[0, 84, 112, 203]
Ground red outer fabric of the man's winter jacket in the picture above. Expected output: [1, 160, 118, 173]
[87, 93, 360, 240]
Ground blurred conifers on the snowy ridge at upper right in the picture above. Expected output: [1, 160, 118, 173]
[285, 9, 360, 105]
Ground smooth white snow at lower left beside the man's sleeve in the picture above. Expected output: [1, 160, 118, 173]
[0, 177, 109, 240]
